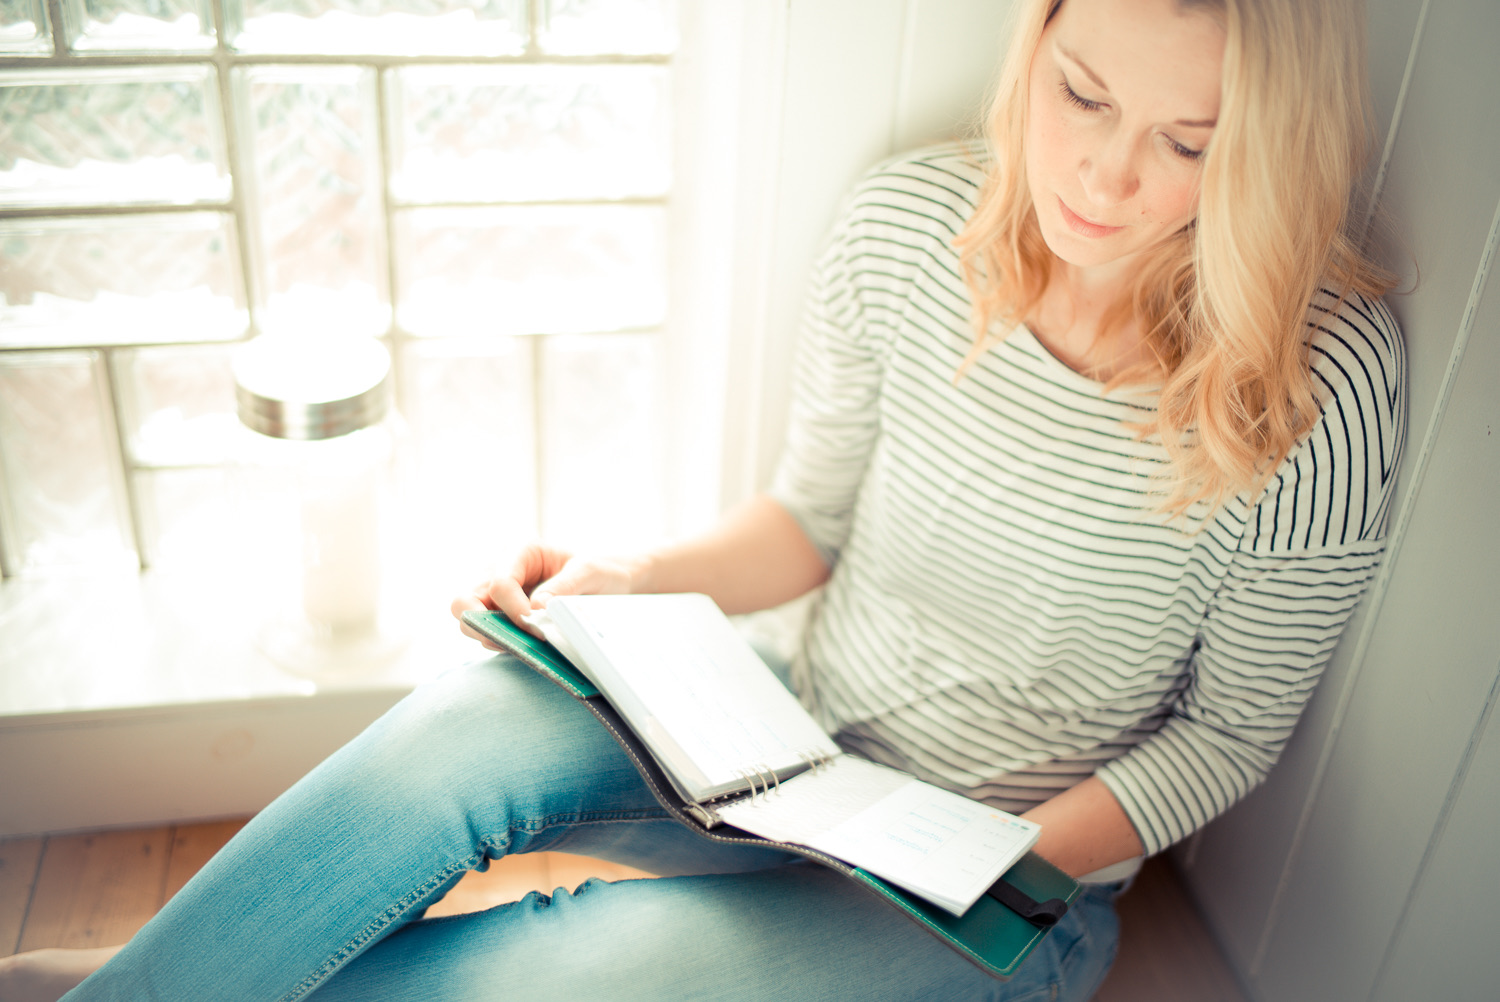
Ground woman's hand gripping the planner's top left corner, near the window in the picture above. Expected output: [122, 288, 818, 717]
[453, 543, 645, 651]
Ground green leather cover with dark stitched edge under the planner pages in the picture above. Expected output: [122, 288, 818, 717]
[464, 612, 1080, 978]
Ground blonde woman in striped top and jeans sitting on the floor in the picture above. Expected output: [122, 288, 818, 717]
[12, 0, 1404, 1002]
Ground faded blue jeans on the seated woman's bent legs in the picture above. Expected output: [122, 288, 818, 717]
[66, 657, 1118, 1002]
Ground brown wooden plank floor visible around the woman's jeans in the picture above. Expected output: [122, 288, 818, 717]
[0, 821, 1244, 1002]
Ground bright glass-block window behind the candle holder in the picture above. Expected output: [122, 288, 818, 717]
[0, 0, 675, 603]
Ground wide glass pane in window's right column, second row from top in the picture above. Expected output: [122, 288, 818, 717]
[390, 66, 671, 203]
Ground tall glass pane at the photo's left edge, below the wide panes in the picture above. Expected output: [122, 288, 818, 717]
[0, 351, 134, 572]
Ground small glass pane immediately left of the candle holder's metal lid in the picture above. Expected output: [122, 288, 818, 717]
[114, 345, 245, 467]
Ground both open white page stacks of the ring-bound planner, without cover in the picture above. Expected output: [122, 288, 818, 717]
[536, 594, 1041, 915]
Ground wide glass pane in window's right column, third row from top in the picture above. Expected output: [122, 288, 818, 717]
[396, 206, 666, 335]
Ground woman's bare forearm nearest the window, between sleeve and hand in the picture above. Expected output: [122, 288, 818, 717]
[630, 495, 828, 615]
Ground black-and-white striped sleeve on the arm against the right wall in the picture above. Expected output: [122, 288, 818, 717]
[1100, 289, 1406, 852]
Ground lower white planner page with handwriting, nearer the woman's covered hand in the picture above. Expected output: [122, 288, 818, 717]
[719, 755, 1041, 915]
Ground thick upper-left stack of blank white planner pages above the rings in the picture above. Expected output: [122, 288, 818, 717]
[548, 594, 839, 800]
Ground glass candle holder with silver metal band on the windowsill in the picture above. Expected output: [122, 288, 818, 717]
[234, 335, 405, 678]
